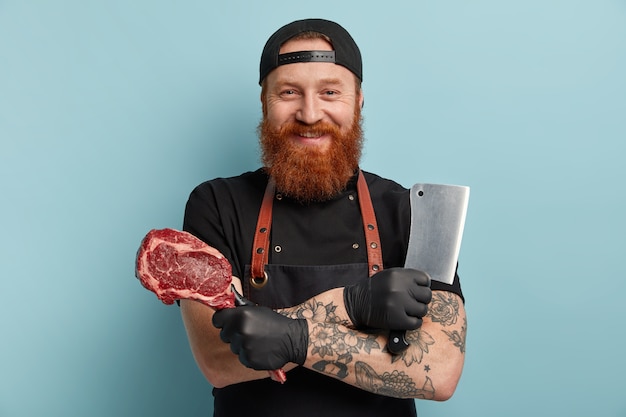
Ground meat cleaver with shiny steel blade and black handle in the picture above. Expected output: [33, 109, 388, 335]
[387, 184, 469, 355]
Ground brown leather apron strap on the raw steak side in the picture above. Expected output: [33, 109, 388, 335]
[251, 178, 276, 287]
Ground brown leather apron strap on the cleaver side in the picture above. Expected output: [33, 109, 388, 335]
[357, 170, 383, 277]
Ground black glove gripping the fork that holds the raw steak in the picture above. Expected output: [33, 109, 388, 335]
[213, 305, 309, 370]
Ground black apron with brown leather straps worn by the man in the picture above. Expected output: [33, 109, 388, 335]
[213, 171, 416, 417]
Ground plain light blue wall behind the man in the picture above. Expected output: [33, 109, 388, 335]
[0, 0, 626, 417]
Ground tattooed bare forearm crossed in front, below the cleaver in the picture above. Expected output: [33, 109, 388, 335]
[282, 289, 467, 400]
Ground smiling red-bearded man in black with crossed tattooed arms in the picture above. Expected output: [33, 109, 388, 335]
[181, 19, 467, 417]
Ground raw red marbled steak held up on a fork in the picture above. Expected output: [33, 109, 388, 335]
[135, 229, 287, 383]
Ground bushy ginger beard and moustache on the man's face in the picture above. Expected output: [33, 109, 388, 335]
[258, 104, 363, 203]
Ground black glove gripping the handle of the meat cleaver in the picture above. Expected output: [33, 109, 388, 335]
[343, 268, 432, 330]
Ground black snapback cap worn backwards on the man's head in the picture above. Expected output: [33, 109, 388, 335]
[259, 19, 363, 84]
